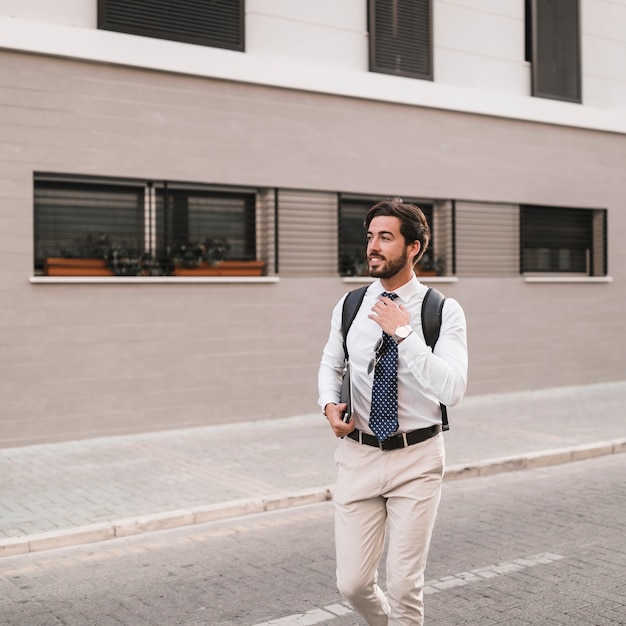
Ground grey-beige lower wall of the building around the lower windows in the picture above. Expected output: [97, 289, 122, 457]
[0, 52, 626, 446]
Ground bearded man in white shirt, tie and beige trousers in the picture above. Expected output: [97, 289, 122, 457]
[318, 198, 467, 626]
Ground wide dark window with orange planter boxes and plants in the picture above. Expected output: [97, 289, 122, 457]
[34, 175, 263, 276]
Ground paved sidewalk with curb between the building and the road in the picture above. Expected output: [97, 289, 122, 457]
[0, 382, 626, 557]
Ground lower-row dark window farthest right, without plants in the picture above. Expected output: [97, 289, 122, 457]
[520, 206, 607, 276]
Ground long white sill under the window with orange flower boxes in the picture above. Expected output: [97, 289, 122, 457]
[29, 276, 280, 285]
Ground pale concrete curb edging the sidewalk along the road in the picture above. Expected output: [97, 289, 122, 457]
[0, 438, 626, 558]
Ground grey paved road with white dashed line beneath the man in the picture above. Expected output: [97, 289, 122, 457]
[0, 454, 626, 626]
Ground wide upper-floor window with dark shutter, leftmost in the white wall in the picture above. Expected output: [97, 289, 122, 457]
[98, 0, 244, 50]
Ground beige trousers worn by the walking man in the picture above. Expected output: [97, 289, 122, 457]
[334, 433, 445, 626]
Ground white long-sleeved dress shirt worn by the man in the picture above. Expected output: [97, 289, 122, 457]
[318, 276, 467, 433]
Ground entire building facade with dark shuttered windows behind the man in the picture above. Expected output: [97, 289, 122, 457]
[0, 0, 626, 446]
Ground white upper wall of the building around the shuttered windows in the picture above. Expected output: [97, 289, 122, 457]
[0, 0, 626, 133]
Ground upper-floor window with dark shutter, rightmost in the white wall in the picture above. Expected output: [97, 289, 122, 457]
[525, 0, 582, 102]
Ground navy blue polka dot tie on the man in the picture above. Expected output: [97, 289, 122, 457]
[369, 291, 398, 441]
